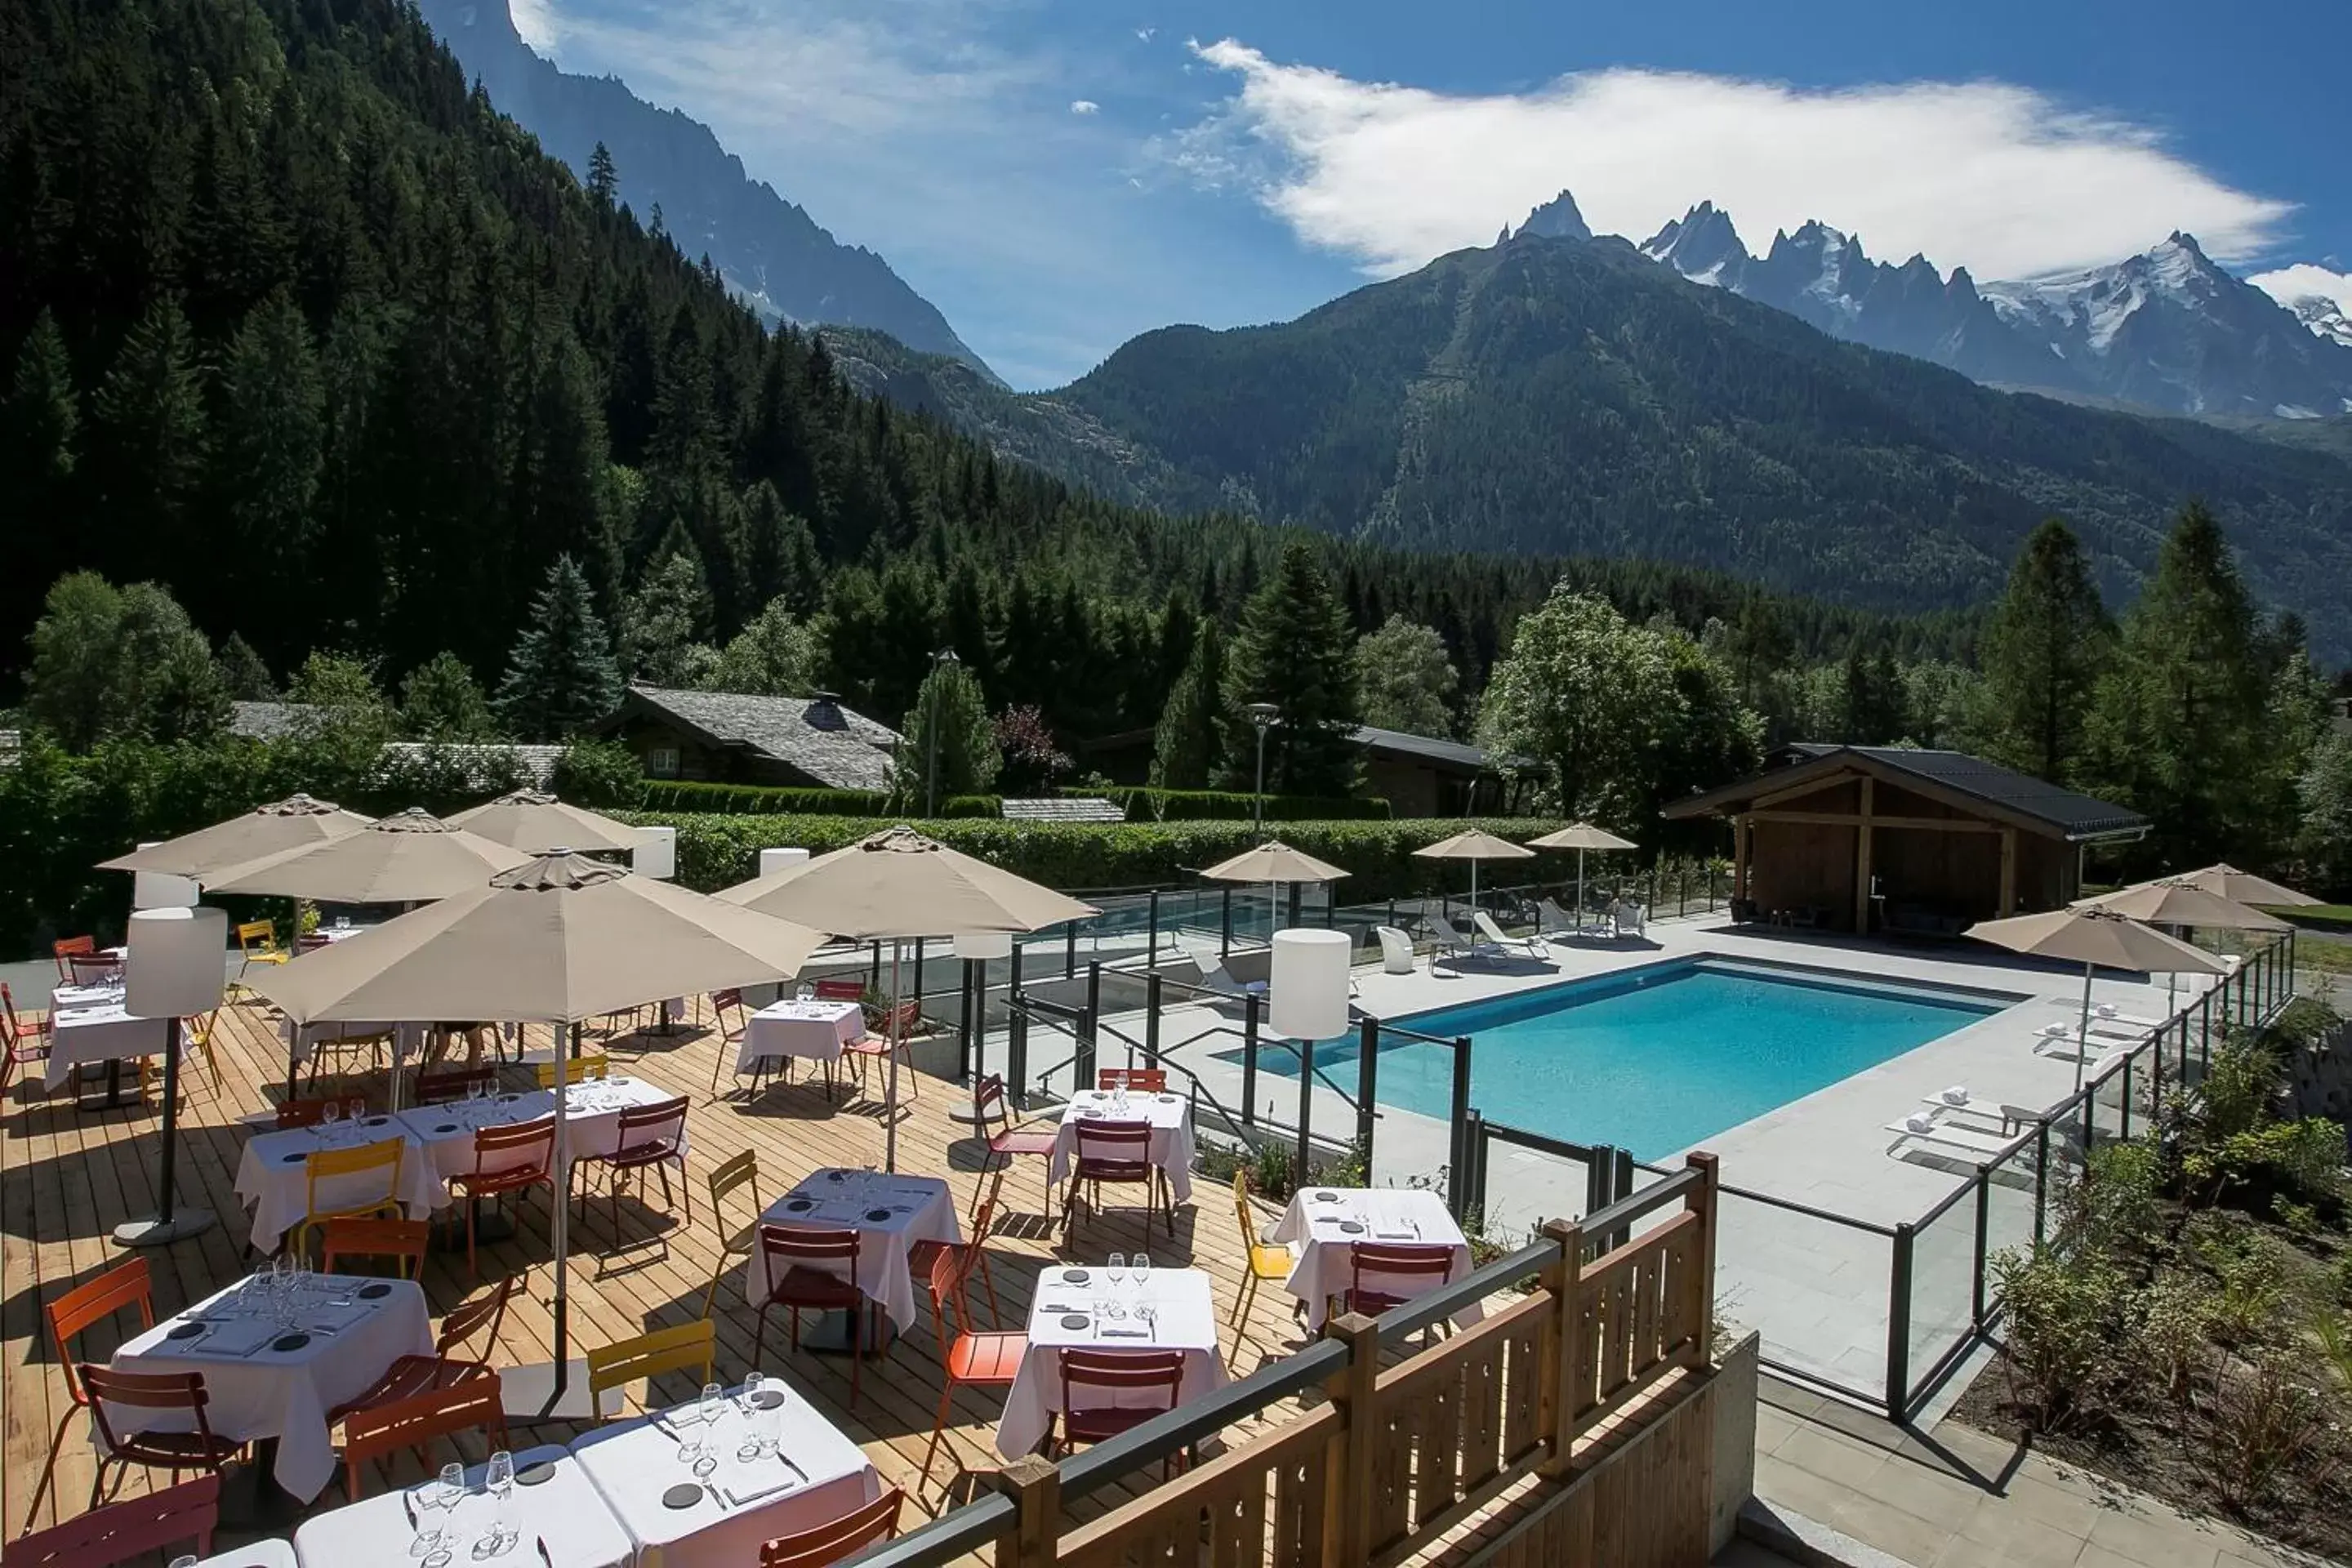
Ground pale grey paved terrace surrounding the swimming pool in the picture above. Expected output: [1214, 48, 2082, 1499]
[988, 917, 2238, 1415]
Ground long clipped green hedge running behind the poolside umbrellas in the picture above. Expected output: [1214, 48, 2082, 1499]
[617, 811, 1571, 902]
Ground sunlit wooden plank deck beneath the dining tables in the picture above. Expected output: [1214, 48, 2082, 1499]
[0, 1004, 1301, 1542]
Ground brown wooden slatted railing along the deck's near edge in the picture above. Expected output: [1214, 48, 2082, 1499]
[856, 1154, 1717, 1568]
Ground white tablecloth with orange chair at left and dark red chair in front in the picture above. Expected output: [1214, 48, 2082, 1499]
[997, 1265, 1225, 1458]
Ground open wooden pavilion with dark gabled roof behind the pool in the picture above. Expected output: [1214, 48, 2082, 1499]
[1663, 746, 2147, 936]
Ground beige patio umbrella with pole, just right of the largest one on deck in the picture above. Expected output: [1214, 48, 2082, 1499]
[717, 822, 1096, 1171]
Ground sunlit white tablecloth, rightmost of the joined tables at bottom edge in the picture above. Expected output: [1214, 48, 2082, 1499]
[571, 1378, 882, 1568]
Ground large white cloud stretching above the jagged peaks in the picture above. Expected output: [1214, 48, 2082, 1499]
[1162, 38, 2291, 278]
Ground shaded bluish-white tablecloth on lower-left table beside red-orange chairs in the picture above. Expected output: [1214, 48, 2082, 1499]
[110, 1276, 433, 1502]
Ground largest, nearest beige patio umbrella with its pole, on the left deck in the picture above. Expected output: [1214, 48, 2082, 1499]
[254, 853, 823, 1413]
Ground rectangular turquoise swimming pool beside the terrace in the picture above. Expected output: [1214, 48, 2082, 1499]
[1218, 959, 2016, 1159]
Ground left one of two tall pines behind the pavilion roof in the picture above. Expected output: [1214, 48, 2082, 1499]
[1985, 517, 2114, 783]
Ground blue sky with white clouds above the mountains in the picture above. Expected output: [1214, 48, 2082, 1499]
[513, 0, 2352, 388]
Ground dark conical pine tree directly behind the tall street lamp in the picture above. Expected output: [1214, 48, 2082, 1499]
[1225, 543, 1360, 795]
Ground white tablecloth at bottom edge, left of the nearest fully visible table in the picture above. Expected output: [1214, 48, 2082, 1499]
[294, 1443, 637, 1568]
